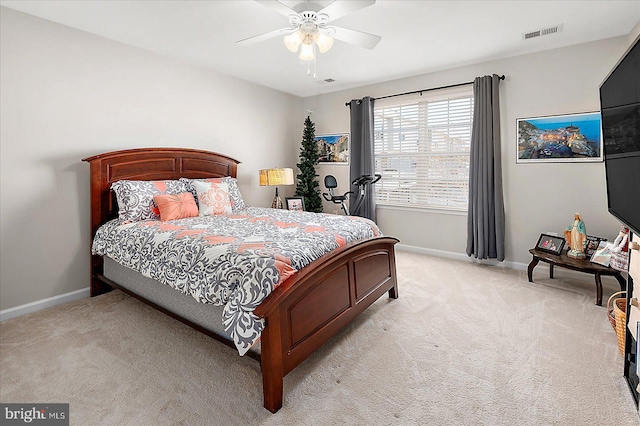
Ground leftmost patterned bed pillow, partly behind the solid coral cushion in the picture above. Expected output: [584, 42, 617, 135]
[111, 180, 189, 223]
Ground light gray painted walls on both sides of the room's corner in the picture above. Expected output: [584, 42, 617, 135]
[0, 8, 640, 310]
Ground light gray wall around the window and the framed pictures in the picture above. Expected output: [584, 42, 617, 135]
[304, 36, 629, 263]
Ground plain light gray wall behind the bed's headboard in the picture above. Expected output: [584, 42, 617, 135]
[0, 8, 306, 310]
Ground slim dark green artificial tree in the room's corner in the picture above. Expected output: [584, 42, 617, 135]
[296, 116, 322, 213]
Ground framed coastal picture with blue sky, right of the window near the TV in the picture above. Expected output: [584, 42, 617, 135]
[516, 112, 603, 163]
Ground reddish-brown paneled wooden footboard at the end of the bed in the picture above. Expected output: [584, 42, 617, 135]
[254, 237, 398, 413]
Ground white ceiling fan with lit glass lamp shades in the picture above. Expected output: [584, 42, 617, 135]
[236, 0, 381, 56]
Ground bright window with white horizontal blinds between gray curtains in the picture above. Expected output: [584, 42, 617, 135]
[374, 85, 473, 211]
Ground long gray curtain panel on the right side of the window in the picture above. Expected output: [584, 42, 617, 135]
[467, 74, 504, 261]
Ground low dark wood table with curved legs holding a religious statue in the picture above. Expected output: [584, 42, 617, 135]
[527, 249, 627, 306]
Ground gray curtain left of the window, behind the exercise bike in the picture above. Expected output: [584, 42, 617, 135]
[349, 96, 376, 222]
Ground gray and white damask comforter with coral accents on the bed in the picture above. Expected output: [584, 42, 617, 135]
[92, 207, 381, 355]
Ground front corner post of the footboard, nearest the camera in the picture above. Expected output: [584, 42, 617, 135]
[260, 309, 284, 413]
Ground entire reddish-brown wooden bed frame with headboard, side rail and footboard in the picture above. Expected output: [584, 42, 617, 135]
[83, 148, 398, 413]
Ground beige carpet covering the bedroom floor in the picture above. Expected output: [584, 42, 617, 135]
[0, 252, 638, 425]
